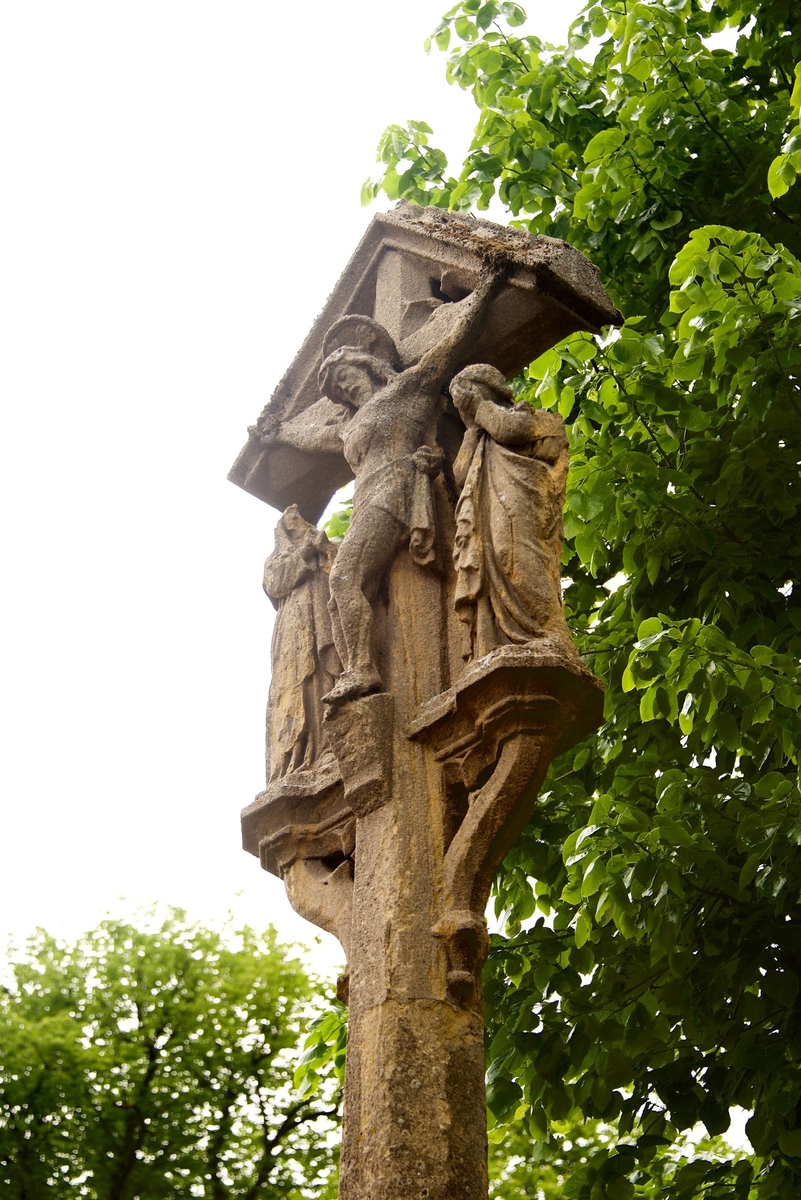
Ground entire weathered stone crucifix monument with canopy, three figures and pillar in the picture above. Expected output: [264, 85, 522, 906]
[230, 203, 621, 1200]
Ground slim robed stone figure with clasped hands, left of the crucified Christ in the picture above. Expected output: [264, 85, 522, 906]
[264, 504, 341, 784]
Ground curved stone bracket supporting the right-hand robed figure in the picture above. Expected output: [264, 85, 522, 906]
[408, 646, 603, 1007]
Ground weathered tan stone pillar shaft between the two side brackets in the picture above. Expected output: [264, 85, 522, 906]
[332, 558, 487, 1200]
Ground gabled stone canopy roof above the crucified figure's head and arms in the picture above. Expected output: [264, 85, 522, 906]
[228, 200, 622, 522]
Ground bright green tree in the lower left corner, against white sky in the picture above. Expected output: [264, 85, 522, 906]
[0, 911, 336, 1200]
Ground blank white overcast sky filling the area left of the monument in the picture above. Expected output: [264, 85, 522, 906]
[0, 0, 579, 964]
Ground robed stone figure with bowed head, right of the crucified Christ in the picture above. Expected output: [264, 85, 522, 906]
[451, 364, 577, 658]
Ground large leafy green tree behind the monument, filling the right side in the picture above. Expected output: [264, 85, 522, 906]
[365, 0, 801, 1200]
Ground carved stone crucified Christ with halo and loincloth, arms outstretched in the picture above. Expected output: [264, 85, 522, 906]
[267, 266, 506, 704]
